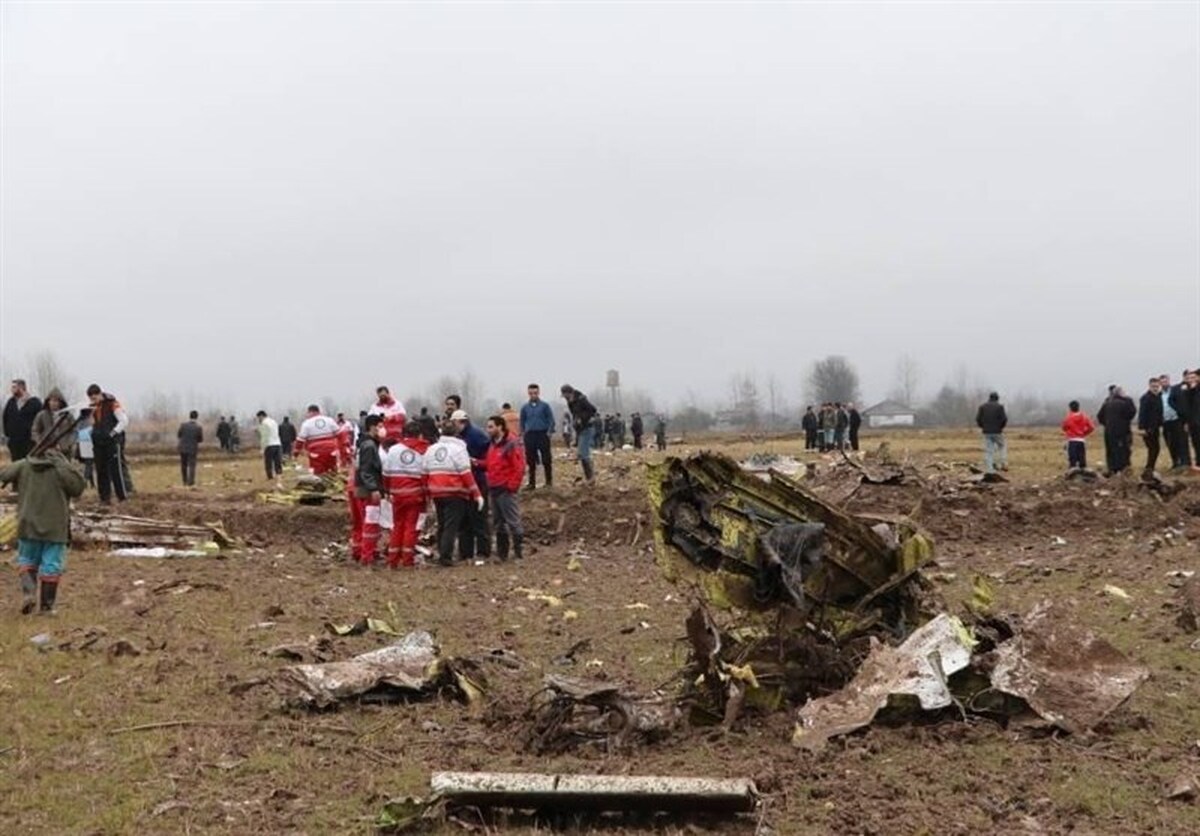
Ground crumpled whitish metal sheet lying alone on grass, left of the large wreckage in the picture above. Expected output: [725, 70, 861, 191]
[277, 631, 485, 708]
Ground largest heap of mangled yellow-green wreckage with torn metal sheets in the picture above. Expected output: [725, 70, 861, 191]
[650, 453, 1148, 750]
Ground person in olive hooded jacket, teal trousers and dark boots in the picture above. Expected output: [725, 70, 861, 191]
[0, 447, 86, 615]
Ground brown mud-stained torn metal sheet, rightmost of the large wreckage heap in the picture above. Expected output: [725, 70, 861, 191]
[991, 601, 1150, 733]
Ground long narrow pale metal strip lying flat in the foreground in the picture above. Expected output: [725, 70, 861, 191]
[430, 772, 758, 813]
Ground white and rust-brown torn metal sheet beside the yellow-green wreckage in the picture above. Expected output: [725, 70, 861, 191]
[792, 614, 974, 751]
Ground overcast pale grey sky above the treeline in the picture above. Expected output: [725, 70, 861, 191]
[0, 2, 1200, 409]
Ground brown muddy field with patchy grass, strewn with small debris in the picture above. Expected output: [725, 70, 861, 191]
[0, 433, 1200, 834]
